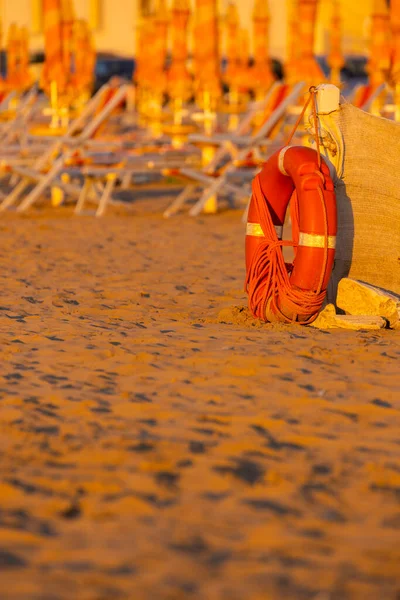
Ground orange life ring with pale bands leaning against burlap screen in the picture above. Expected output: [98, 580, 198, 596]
[245, 146, 337, 324]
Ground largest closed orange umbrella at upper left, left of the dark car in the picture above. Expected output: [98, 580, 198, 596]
[42, 0, 66, 94]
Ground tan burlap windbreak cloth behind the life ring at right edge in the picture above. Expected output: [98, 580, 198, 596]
[328, 103, 400, 301]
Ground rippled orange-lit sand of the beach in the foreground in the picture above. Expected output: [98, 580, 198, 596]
[0, 198, 400, 600]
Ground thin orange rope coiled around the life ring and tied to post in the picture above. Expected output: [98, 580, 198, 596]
[245, 88, 328, 325]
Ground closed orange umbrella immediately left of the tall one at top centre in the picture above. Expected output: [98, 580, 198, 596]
[168, 0, 191, 100]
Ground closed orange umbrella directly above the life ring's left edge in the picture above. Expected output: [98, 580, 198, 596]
[251, 0, 274, 97]
